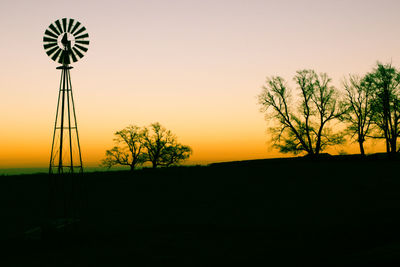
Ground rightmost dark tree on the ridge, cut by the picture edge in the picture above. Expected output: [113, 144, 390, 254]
[366, 62, 400, 154]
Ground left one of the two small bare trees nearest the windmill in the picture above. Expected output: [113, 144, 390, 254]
[102, 125, 147, 171]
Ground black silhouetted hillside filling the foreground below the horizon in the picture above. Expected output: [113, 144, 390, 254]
[0, 156, 400, 266]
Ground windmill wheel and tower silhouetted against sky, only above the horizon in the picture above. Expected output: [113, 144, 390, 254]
[43, 18, 89, 174]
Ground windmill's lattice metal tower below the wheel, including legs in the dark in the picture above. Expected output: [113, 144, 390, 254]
[48, 64, 86, 232]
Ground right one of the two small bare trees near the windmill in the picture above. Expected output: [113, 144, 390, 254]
[143, 122, 192, 168]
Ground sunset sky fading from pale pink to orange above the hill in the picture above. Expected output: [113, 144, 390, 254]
[0, 0, 400, 168]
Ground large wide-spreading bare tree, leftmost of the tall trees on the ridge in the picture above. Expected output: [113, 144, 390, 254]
[258, 70, 344, 156]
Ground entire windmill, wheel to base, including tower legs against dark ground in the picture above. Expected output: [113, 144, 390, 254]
[43, 18, 89, 228]
